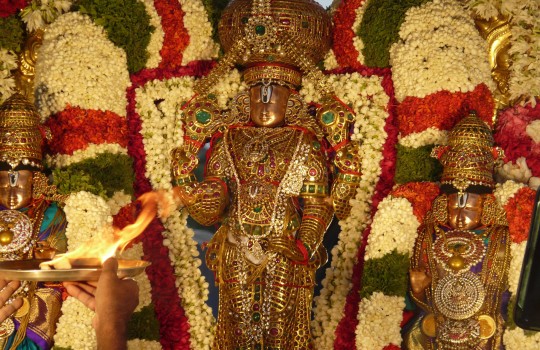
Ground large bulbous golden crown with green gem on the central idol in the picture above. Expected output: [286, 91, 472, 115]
[195, 0, 332, 93]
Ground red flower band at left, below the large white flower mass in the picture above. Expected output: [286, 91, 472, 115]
[45, 106, 128, 155]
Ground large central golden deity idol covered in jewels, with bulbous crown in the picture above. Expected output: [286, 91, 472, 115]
[172, 0, 360, 350]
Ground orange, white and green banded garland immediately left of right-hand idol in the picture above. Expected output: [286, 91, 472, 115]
[356, 182, 439, 349]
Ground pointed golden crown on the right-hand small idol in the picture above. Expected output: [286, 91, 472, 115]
[434, 112, 497, 192]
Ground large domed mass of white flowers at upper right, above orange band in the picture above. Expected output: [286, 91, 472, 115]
[390, 0, 495, 102]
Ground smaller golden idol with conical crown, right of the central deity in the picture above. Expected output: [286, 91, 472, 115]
[406, 113, 510, 349]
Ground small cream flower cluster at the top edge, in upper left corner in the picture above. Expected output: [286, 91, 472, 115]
[21, 0, 72, 33]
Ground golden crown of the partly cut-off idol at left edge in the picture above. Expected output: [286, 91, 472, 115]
[0, 93, 43, 169]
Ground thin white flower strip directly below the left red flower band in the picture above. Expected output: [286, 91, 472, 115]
[45, 143, 128, 168]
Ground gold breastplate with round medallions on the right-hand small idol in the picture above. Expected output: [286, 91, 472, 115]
[422, 230, 508, 349]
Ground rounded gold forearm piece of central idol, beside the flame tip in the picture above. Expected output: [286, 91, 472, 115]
[185, 178, 229, 226]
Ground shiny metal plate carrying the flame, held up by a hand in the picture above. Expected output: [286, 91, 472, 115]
[0, 259, 150, 282]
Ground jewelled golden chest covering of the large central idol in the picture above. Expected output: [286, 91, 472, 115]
[226, 127, 307, 235]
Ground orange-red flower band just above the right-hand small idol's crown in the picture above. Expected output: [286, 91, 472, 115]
[397, 84, 495, 136]
